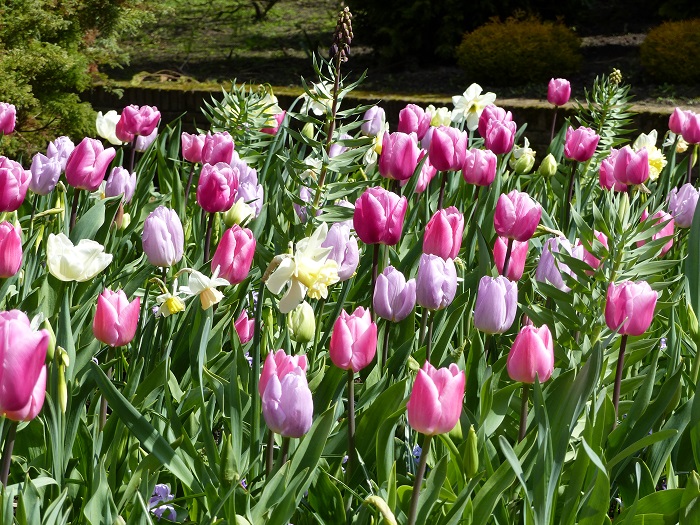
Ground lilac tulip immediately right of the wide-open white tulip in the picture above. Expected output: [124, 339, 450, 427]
[141, 206, 185, 267]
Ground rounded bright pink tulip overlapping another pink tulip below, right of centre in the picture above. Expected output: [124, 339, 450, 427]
[493, 190, 542, 242]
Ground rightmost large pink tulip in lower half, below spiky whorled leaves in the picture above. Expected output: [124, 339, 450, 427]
[605, 281, 658, 335]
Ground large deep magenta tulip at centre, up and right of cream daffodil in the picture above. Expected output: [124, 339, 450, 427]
[353, 187, 408, 246]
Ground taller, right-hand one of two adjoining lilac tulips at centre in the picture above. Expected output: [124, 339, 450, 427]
[416, 253, 457, 310]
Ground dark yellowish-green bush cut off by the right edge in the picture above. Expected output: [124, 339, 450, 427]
[640, 19, 700, 84]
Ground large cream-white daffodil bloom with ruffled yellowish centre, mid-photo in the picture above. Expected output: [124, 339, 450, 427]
[265, 222, 338, 314]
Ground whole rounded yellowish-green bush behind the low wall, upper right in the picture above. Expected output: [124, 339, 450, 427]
[457, 17, 581, 85]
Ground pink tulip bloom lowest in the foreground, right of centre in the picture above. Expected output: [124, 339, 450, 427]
[406, 361, 466, 436]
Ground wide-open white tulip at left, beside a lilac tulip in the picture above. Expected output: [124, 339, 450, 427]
[46, 233, 112, 283]
